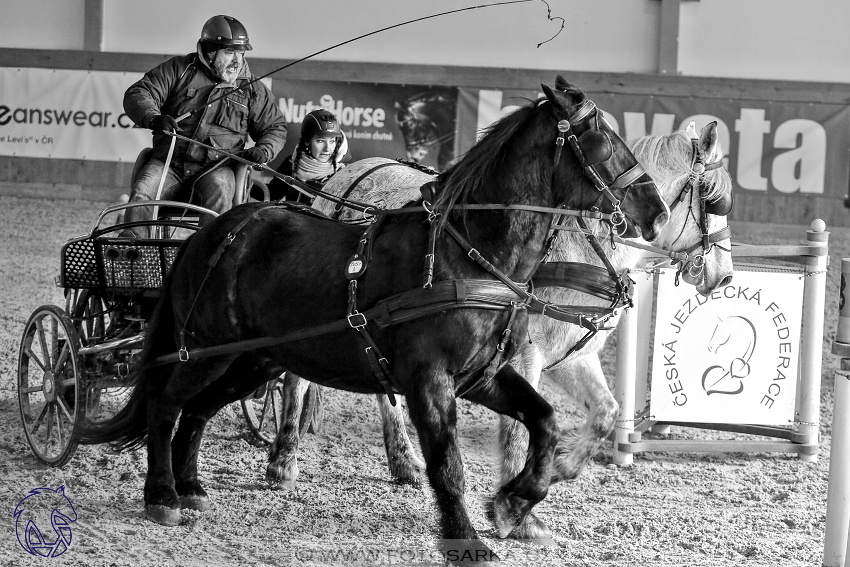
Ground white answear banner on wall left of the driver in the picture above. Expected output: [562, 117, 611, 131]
[0, 67, 151, 162]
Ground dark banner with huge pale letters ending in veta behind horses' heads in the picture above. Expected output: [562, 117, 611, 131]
[458, 89, 850, 204]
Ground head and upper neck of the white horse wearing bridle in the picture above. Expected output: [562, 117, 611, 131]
[631, 122, 732, 295]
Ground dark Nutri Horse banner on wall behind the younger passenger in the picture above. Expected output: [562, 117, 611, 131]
[272, 78, 457, 170]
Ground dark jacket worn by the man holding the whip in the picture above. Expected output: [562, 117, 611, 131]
[124, 53, 286, 179]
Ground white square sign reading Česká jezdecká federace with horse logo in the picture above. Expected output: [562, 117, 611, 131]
[650, 270, 803, 425]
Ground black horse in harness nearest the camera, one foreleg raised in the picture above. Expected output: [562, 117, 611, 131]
[81, 77, 669, 564]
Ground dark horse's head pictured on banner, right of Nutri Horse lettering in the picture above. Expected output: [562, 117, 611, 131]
[395, 91, 457, 171]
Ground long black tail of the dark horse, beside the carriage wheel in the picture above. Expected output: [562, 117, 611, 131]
[79, 239, 188, 451]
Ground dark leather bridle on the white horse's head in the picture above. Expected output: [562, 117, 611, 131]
[670, 138, 732, 282]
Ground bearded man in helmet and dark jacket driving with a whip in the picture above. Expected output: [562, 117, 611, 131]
[123, 16, 286, 236]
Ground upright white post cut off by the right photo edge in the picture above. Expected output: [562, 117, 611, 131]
[823, 258, 850, 567]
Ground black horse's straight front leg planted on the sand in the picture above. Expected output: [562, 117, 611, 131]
[404, 368, 498, 565]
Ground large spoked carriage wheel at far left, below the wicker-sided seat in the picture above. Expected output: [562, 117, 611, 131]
[18, 305, 84, 467]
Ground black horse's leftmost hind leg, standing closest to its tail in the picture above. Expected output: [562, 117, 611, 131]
[140, 358, 232, 526]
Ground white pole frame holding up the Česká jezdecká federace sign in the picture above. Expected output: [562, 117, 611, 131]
[614, 219, 828, 466]
